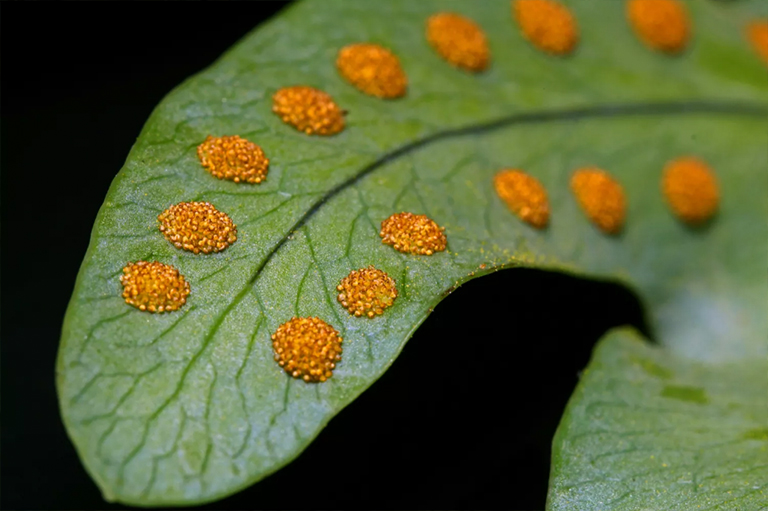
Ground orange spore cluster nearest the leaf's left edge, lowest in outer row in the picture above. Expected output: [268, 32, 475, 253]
[120, 261, 189, 312]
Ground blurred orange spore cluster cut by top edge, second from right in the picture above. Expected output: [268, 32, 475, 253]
[627, 0, 691, 53]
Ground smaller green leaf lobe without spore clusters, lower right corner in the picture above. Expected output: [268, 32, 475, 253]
[548, 330, 768, 511]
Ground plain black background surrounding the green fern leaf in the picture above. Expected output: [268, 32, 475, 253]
[0, 2, 642, 509]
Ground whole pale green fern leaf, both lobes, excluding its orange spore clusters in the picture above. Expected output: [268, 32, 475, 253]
[57, 0, 768, 510]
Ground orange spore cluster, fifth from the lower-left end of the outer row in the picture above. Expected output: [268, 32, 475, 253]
[336, 43, 408, 99]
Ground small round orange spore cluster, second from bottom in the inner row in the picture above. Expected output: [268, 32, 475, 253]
[336, 266, 397, 318]
